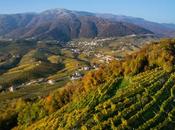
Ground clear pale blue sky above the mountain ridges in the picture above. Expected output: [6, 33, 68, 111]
[0, 0, 175, 23]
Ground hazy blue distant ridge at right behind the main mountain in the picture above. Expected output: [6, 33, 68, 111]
[96, 14, 175, 37]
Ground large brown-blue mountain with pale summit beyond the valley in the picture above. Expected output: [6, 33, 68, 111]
[0, 9, 152, 41]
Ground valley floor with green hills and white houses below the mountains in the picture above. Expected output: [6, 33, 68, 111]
[0, 35, 158, 97]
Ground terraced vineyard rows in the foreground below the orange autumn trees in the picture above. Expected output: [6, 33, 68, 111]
[20, 68, 175, 130]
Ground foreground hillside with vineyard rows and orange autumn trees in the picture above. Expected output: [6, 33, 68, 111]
[0, 39, 175, 130]
